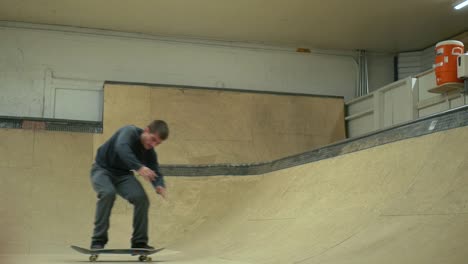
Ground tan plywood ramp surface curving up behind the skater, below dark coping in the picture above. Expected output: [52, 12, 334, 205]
[0, 127, 468, 264]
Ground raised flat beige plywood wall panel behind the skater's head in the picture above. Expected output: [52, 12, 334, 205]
[95, 84, 345, 164]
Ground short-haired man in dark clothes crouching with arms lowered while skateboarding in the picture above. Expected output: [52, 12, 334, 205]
[91, 120, 169, 249]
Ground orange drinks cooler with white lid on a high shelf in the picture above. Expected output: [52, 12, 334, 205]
[434, 40, 465, 85]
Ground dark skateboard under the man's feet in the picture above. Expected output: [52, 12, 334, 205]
[71, 245, 164, 262]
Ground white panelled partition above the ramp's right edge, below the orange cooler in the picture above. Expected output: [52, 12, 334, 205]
[345, 67, 468, 137]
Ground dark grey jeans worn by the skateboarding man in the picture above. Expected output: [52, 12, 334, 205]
[91, 164, 150, 245]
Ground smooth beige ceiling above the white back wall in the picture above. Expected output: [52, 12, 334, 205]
[0, 0, 468, 52]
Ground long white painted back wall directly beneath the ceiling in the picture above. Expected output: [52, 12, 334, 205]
[0, 22, 357, 120]
